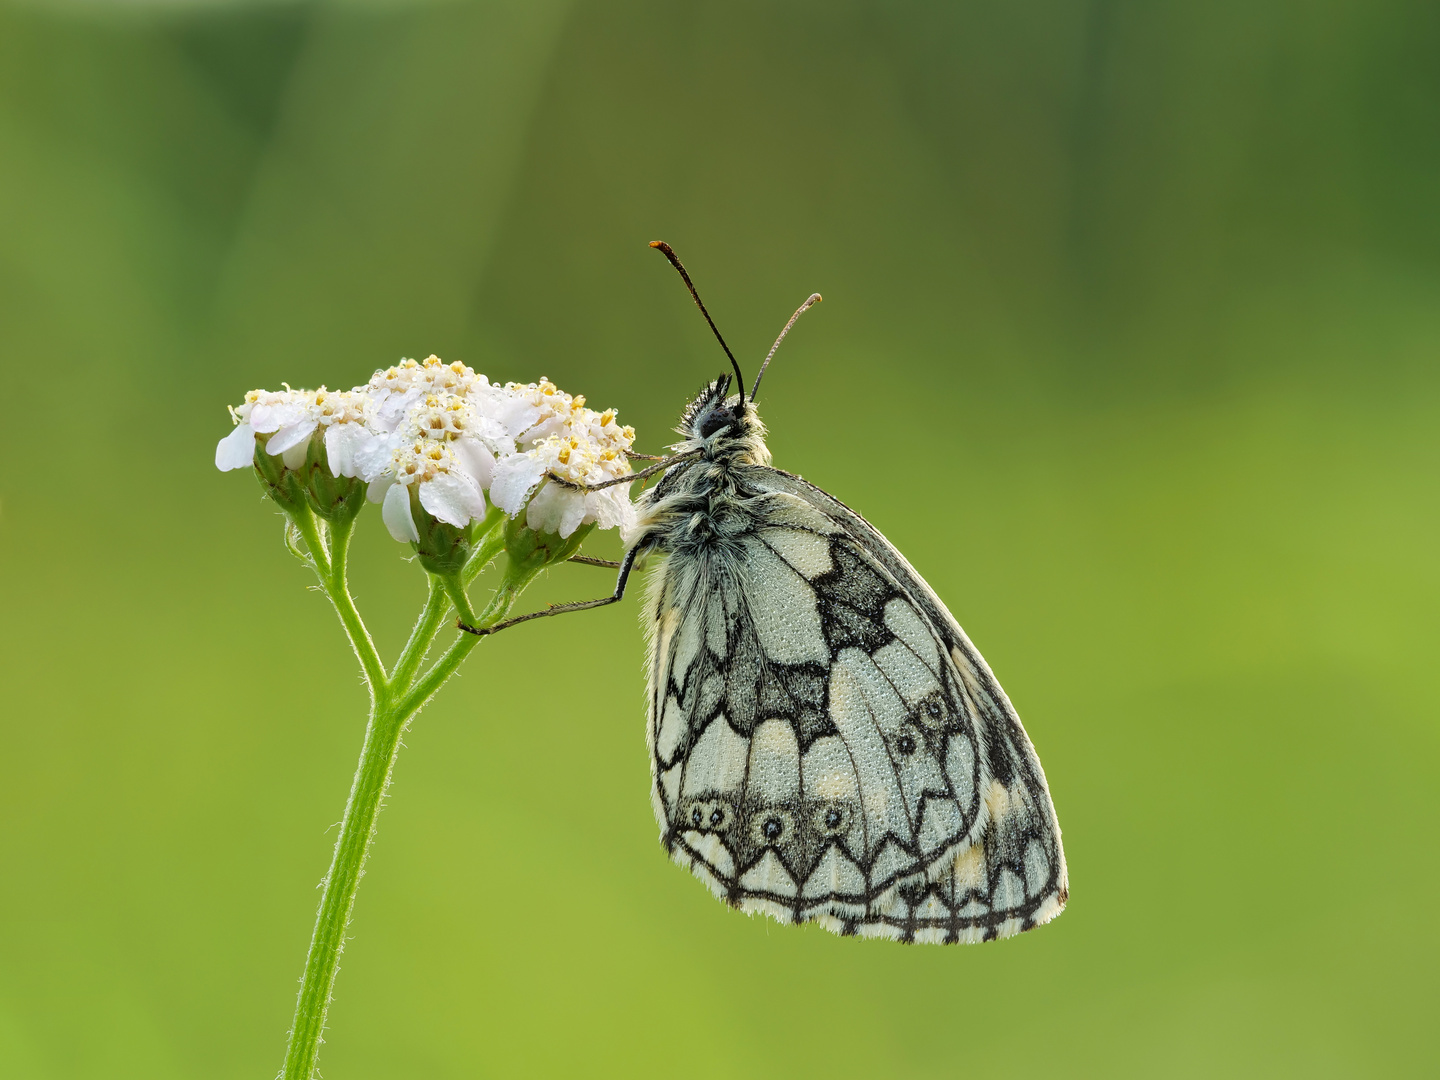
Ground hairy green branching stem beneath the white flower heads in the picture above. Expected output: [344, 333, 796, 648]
[282, 514, 518, 1080]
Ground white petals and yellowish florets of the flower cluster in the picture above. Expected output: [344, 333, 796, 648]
[215, 356, 635, 541]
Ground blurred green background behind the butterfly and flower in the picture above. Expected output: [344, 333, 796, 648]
[0, 0, 1440, 1080]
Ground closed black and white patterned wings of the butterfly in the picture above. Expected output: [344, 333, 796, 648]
[647, 467, 1067, 943]
